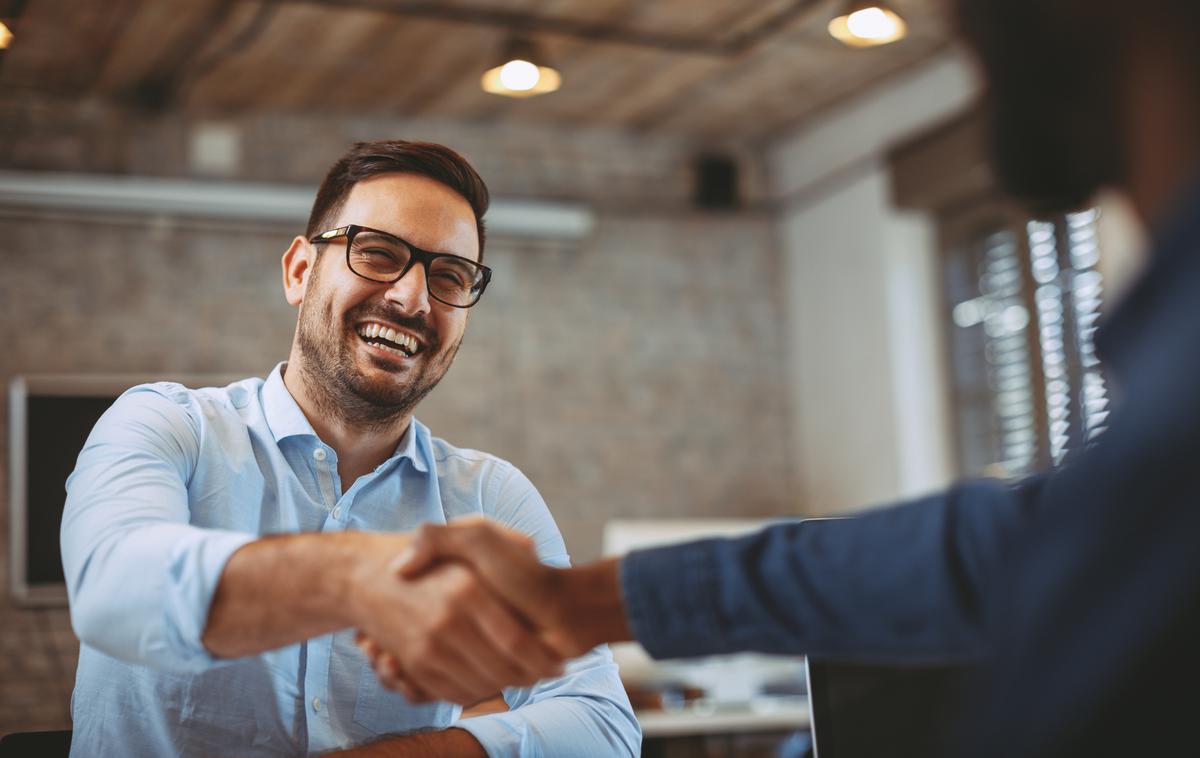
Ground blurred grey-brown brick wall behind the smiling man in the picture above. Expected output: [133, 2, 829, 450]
[0, 100, 800, 734]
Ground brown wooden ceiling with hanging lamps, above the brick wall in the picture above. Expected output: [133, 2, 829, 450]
[0, 0, 949, 142]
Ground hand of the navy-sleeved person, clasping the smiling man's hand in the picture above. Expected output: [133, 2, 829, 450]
[360, 518, 630, 698]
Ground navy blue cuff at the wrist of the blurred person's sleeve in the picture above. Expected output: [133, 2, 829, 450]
[620, 540, 731, 658]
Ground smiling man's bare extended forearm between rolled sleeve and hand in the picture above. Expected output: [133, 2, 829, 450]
[202, 531, 408, 657]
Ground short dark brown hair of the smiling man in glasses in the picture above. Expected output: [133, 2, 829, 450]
[305, 139, 488, 260]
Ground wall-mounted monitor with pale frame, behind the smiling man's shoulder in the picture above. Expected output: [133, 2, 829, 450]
[8, 374, 244, 606]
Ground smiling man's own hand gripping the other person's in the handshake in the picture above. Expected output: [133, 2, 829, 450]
[349, 534, 562, 705]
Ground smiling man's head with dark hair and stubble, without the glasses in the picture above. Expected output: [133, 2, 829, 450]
[283, 142, 487, 426]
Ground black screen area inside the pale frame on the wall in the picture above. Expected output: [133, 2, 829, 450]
[25, 396, 115, 588]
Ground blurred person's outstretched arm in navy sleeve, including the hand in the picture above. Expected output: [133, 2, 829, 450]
[401, 479, 1043, 662]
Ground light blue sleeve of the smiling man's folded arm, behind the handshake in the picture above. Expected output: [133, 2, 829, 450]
[455, 465, 642, 758]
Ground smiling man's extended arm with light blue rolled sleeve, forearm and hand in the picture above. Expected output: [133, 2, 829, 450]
[62, 391, 559, 702]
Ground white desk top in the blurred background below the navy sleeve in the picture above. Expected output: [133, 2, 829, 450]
[637, 697, 809, 738]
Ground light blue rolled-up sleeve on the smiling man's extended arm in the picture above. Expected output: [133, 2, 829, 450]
[60, 386, 254, 670]
